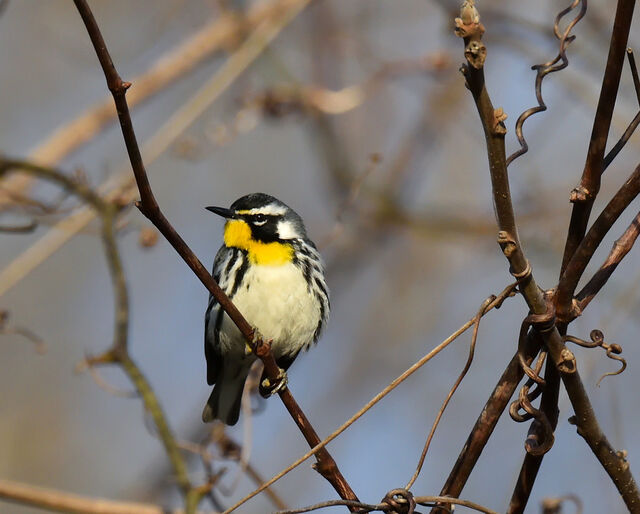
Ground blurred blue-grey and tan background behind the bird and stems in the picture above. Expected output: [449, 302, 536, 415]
[0, 0, 640, 514]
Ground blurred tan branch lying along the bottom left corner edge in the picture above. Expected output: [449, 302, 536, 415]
[0, 479, 192, 514]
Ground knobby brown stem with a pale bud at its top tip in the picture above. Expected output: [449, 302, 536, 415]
[444, 6, 640, 511]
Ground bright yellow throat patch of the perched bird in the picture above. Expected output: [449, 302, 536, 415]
[224, 220, 293, 266]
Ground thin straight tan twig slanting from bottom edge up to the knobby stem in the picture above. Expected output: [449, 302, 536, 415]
[224, 283, 517, 514]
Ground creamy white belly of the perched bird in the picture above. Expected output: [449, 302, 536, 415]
[220, 264, 320, 358]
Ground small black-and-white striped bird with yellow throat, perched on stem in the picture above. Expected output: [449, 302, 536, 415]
[202, 193, 330, 425]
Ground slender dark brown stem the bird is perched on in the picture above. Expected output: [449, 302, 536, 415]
[74, 0, 358, 500]
